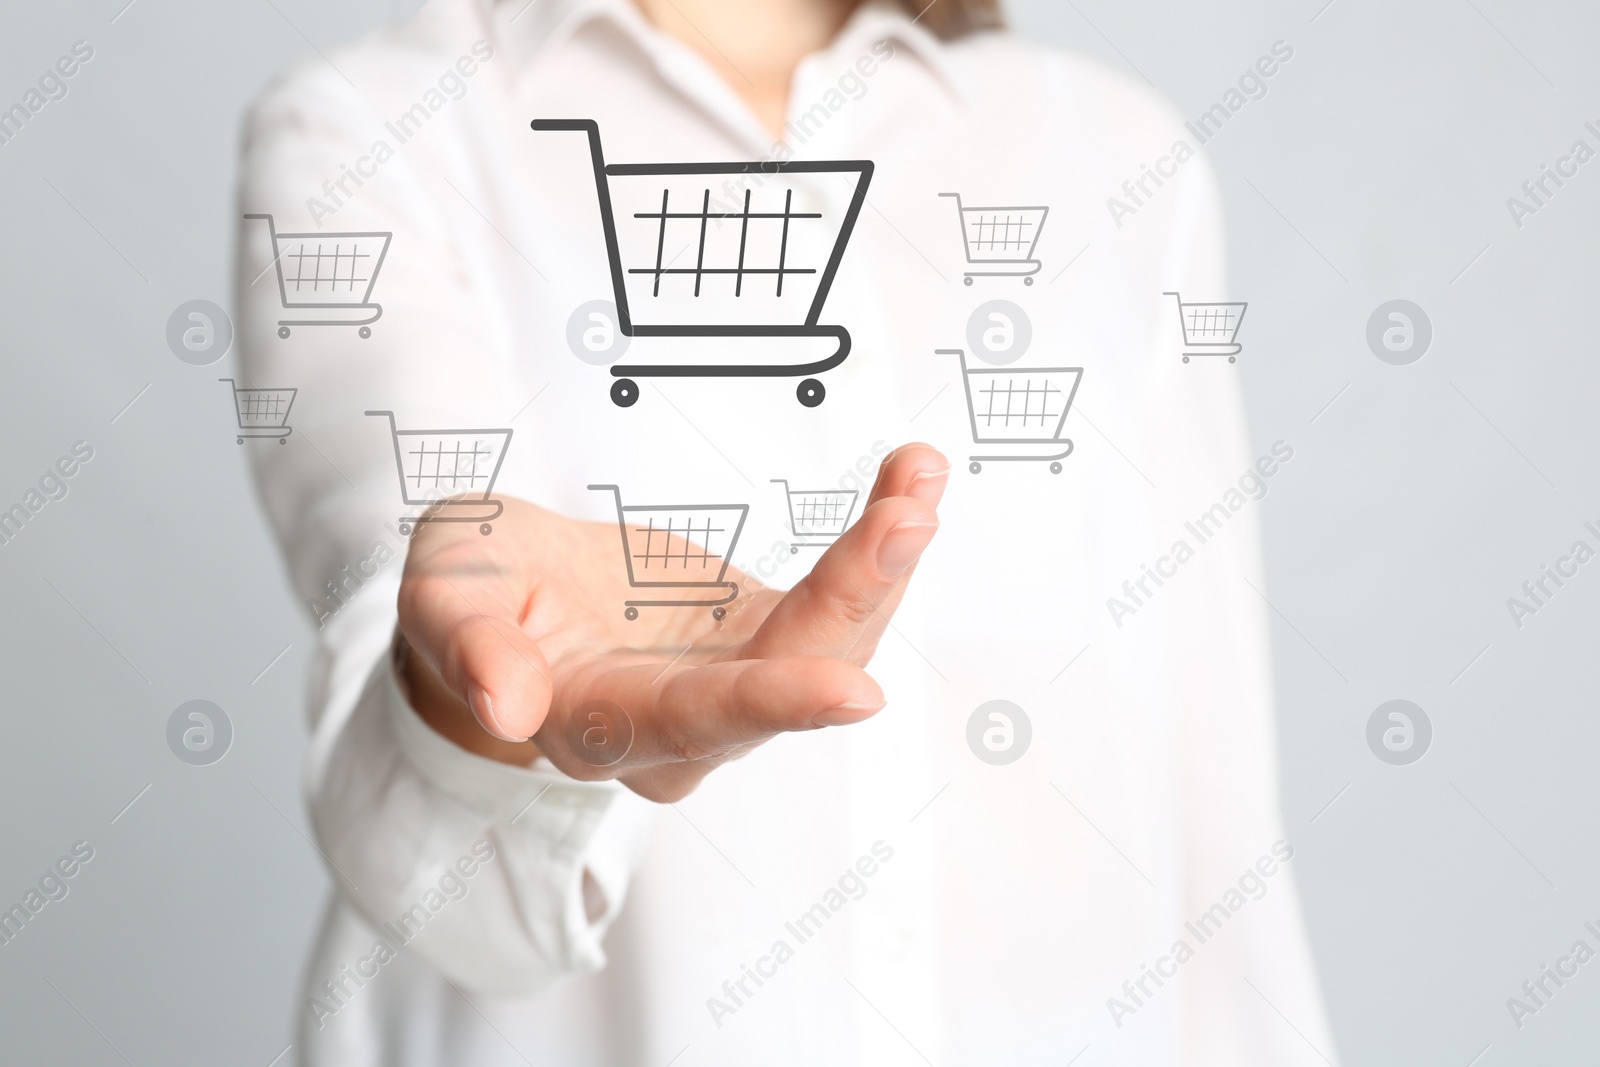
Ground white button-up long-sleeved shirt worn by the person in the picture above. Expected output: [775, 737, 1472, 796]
[237, 0, 1334, 1067]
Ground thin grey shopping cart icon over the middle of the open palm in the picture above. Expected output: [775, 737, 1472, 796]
[589, 485, 750, 621]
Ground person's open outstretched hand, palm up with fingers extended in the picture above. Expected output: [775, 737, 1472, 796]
[400, 445, 949, 800]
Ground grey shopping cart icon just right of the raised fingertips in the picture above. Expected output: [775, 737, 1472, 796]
[938, 349, 1083, 474]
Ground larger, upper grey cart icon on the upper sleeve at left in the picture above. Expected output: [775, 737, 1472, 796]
[245, 214, 394, 338]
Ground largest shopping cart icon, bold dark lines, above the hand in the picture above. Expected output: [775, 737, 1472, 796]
[533, 118, 872, 408]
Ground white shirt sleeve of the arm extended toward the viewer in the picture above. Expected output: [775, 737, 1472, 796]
[235, 58, 653, 993]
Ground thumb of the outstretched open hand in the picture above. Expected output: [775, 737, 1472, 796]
[398, 526, 552, 741]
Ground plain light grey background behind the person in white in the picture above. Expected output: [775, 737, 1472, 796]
[0, 0, 1600, 1067]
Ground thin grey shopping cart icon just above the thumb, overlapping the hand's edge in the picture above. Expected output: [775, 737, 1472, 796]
[366, 411, 510, 534]
